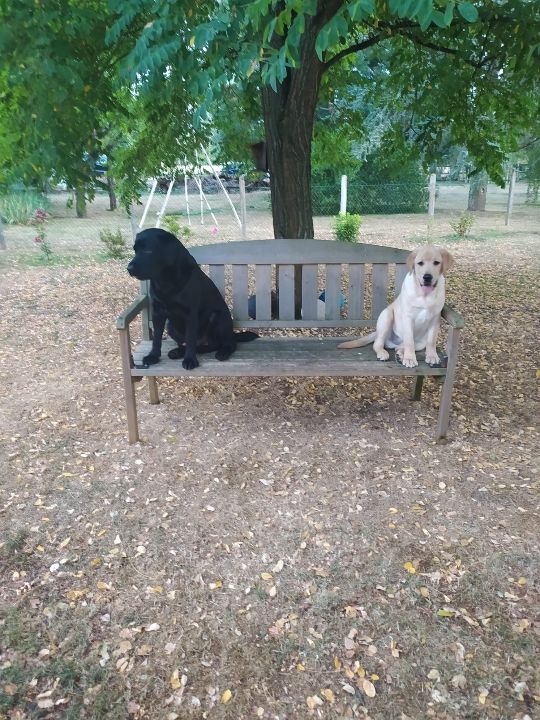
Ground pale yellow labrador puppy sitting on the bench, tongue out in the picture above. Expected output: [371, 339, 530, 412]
[338, 246, 454, 367]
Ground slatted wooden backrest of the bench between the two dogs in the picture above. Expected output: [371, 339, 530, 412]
[143, 240, 409, 328]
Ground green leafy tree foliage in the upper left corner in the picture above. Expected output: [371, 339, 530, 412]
[0, 0, 140, 217]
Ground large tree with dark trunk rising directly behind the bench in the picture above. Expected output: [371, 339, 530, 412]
[111, 0, 540, 237]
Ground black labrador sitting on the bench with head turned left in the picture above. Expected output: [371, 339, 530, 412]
[127, 228, 258, 370]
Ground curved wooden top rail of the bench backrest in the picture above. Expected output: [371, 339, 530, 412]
[189, 239, 409, 265]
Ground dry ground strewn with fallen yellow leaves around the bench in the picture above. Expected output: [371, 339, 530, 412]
[0, 202, 540, 720]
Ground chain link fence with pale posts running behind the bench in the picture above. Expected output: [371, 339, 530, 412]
[0, 178, 539, 266]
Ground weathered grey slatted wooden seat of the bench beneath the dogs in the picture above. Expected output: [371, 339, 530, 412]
[131, 337, 446, 379]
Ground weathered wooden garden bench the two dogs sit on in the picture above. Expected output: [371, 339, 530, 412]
[116, 240, 463, 443]
